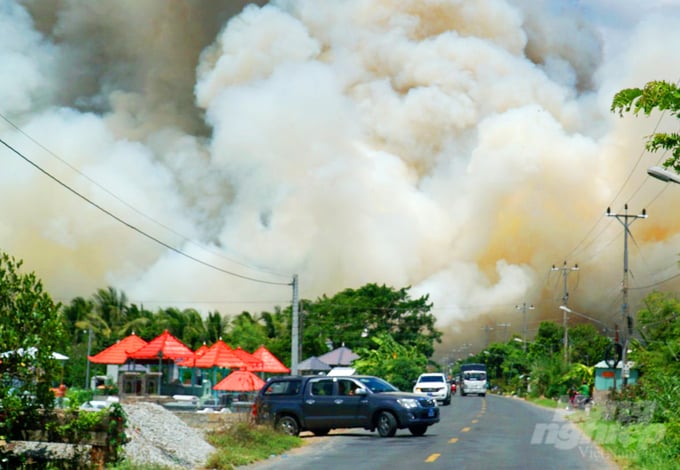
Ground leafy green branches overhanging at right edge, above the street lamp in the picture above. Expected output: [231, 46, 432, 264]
[611, 80, 680, 173]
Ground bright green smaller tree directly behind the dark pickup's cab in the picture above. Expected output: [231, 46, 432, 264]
[353, 333, 427, 391]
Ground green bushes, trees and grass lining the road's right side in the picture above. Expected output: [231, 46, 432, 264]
[468, 292, 680, 470]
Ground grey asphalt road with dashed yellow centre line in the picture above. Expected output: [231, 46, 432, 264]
[239, 395, 618, 470]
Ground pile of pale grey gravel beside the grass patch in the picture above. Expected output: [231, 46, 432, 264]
[122, 403, 215, 470]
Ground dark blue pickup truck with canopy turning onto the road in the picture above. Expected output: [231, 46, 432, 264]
[253, 375, 439, 437]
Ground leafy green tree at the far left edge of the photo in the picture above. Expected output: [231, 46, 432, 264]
[0, 253, 64, 439]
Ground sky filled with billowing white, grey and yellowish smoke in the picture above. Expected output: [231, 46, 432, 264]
[0, 0, 680, 355]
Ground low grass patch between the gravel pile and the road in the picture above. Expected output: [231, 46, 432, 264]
[206, 421, 302, 470]
